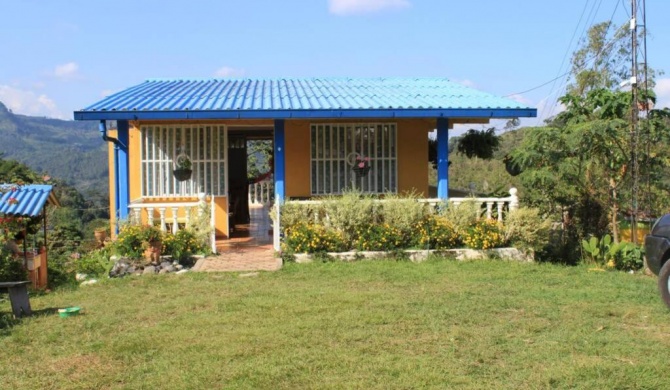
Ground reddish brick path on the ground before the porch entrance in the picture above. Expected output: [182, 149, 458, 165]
[194, 245, 282, 272]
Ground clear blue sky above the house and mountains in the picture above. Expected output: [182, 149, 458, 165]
[0, 0, 670, 131]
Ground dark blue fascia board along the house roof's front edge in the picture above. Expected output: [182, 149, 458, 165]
[74, 108, 537, 120]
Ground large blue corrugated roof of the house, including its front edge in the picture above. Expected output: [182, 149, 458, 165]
[74, 78, 537, 120]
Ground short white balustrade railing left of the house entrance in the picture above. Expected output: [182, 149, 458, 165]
[128, 194, 209, 234]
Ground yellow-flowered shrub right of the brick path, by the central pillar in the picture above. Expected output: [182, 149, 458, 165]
[282, 223, 346, 253]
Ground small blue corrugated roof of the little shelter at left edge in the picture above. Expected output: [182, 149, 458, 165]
[0, 184, 58, 217]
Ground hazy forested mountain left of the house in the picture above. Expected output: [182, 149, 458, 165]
[0, 102, 109, 194]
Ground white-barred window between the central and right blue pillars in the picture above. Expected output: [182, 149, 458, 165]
[311, 123, 398, 195]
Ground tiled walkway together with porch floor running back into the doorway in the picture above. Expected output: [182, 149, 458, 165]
[194, 206, 282, 272]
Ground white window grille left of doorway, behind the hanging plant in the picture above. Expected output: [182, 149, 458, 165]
[141, 124, 228, 198]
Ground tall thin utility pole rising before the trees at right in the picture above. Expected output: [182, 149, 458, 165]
[630, 0, 640, 243]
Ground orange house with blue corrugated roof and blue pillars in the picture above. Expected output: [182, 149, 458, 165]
[74, 78, 536, 250]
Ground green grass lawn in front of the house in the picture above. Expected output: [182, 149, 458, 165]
[0, 260, 670, 389]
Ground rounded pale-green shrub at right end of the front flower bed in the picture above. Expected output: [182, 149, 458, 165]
[504, 207, 551, 251]
